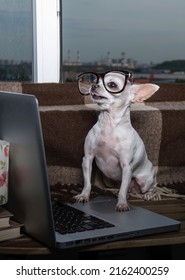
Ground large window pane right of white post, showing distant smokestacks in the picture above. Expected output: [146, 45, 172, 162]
[63, 0, 185, 82]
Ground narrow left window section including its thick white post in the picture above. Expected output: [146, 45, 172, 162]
[0, 0, 61, 83]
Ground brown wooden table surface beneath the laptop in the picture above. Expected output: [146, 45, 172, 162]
[0, 199, 185, 255]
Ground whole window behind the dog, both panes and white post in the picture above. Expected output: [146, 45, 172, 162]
[0, 0, 185, 83]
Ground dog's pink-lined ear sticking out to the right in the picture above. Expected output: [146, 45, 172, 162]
[131, 84, 159, 102]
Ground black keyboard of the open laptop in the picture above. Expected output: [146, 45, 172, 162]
[53, 201, 114, 234]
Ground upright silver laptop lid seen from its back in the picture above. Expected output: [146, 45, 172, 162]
[0, 92, 55, 247]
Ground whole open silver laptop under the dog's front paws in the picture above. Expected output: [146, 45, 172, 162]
[0, 92, 180, 248]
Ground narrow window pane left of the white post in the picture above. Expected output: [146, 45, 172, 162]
[0, 0, 33, 81]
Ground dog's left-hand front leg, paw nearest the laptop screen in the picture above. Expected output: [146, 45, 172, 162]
[74, 155, 93, 203]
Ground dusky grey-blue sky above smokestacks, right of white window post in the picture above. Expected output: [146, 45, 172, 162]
[62, 0, 185, 63]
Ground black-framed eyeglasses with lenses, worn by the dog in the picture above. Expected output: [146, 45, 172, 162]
[77, 70, 132, 95]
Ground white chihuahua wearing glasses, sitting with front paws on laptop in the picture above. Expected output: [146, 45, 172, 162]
[75, 70, 159, 211]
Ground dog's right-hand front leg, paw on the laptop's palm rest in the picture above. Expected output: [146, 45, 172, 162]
[116, 165, 132, 212]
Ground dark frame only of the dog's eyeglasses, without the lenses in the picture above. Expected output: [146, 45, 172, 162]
[77, 70, 133, 95]
